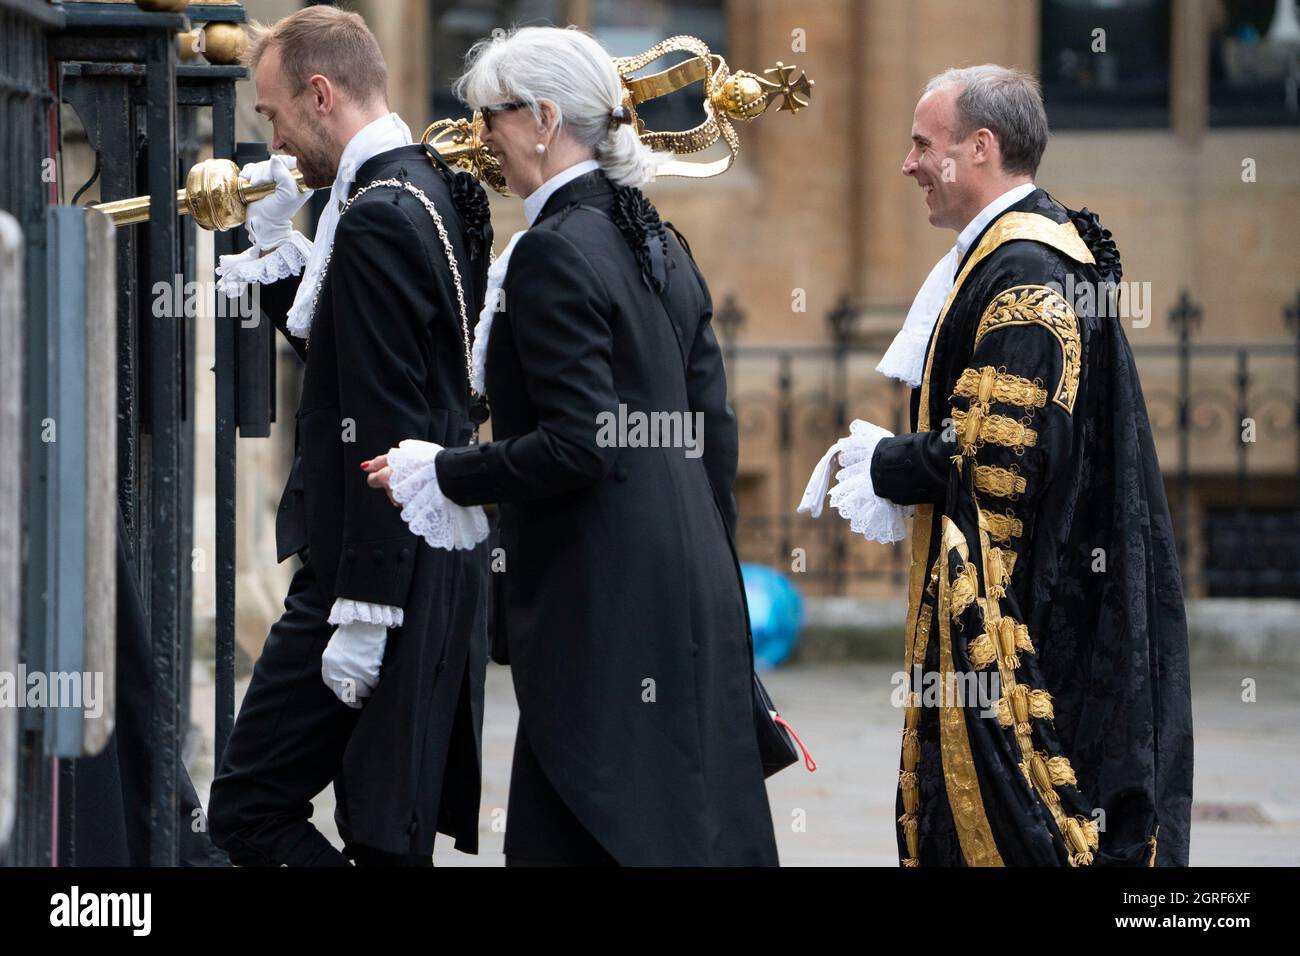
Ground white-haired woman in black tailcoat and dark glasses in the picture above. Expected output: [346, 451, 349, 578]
[371, 27, 776, 865]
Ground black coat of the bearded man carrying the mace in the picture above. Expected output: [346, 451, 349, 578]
[261, 146, 490, 853]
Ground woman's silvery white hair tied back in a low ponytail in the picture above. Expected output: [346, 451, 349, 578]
[454, 26, 672, 186]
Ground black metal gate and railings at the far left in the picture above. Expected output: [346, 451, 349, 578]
[0, 0, 273, 865]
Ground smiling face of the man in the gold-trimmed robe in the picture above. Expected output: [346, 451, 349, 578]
[902, 86, 972, 230]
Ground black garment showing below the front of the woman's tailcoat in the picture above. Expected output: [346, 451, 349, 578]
[506, 721, 618, 866]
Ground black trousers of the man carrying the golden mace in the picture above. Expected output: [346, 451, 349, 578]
[208, 563, 433, 866]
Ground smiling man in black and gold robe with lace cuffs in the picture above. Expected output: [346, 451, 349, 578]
[806, 66, 1192, 866]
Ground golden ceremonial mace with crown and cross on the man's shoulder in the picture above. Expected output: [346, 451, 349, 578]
[91, 36, 813, 232]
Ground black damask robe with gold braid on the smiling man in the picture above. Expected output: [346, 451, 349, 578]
[872, 190, 1192, 866]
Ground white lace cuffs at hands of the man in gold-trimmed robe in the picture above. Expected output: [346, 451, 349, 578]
[798, 419, 911, 545]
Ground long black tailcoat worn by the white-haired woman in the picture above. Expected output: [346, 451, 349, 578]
[437, 170, 776, 865]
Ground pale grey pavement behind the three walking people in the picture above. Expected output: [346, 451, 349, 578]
[189, 662, 1300, 866]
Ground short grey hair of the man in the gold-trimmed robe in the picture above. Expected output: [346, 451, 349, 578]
[922, 64, 1048, 176]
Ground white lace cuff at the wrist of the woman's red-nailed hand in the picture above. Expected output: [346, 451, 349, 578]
[389, 438, 488, 550]
